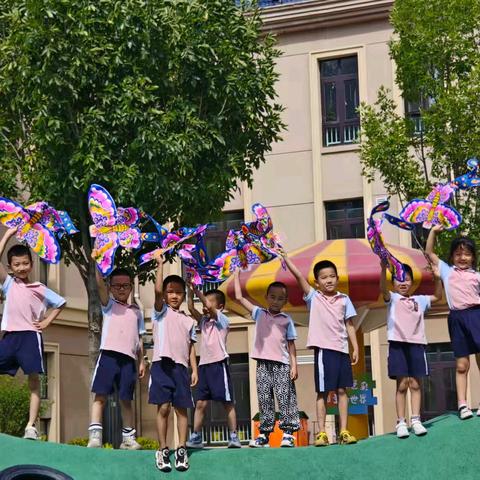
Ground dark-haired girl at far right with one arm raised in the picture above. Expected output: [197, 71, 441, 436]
[425, 225, 480, 420]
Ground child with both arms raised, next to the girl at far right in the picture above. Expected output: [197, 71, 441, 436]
[380, 263, 442, 438]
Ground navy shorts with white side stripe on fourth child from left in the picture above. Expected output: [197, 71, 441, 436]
[195, 359, 234, 403]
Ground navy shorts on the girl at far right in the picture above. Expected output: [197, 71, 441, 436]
[448, 307, 480, 358]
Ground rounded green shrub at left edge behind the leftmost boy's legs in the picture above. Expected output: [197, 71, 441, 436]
[0, 376, 30, 437]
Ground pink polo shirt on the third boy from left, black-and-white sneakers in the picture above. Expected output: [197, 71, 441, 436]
[152, 303, 197, 367]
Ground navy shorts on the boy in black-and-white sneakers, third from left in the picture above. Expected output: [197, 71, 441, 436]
[148, 358, 193, 408]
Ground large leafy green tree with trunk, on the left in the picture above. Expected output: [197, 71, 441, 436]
[0, 0, 283, 368]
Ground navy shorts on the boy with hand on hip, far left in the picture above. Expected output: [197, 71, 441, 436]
[0, 331, 44, 377]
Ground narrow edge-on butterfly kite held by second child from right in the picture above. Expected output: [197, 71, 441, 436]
[367, 200, 413, 282]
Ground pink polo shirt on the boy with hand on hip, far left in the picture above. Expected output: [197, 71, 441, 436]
[1, 275, 65, 332]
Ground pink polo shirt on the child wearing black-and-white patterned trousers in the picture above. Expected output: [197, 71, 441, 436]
[250, 307, 297, 365]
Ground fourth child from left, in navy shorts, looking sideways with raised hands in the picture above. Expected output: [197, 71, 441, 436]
[187, 283, 242, 448]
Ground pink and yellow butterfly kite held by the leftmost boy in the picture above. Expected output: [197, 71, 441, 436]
[0, 197, 78, 263]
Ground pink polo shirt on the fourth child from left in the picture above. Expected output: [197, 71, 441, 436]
[199, 310, 229, 365]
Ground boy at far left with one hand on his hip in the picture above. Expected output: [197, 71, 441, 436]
[0, 228, 65, 440]
